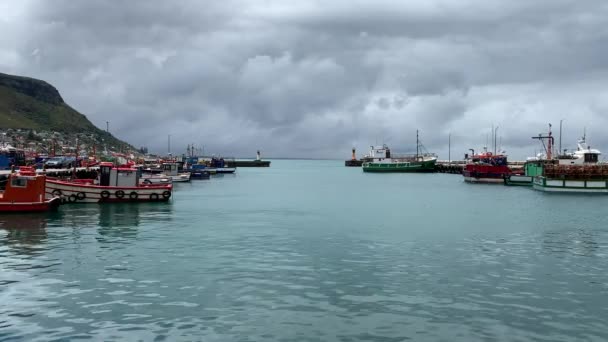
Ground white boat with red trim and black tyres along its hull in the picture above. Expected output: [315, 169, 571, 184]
[46, 163, 173, 203]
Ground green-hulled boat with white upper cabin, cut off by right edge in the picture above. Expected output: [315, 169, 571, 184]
[532, 135, 608, 193]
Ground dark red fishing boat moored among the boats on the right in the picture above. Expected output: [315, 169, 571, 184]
[462, 151, 513, 184]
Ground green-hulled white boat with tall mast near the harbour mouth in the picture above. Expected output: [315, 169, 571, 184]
[362, 131, 437, 173]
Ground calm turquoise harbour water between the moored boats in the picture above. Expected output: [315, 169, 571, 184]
[0, 160, 608, 341]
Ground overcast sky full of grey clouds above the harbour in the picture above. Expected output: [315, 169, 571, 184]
[0, 0, 608, 159]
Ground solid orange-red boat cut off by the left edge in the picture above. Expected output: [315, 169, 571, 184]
[0, 166, 61, 213]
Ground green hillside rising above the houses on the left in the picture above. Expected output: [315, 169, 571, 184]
[0, 73, 132, 147]
